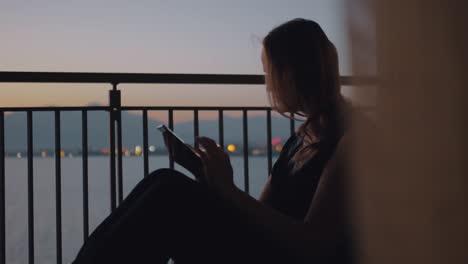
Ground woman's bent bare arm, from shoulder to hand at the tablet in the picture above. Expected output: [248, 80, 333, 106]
[195, 135, 352, 263]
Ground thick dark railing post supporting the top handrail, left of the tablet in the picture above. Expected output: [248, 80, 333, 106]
[109, 83, 122, 212]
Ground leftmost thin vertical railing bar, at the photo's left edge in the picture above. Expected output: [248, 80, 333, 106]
[0, 111, 6, 264]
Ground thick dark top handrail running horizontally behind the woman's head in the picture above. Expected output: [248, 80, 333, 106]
[0, 71, 376, 85]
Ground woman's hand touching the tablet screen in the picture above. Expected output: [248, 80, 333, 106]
[195, 137, 236, 194]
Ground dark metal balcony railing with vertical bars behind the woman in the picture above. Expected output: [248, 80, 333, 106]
[0, 72, 375, 264]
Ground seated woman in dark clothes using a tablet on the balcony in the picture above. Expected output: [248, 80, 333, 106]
[75, 19, 353, 263]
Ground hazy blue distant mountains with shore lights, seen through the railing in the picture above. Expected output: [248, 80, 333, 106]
[5, 111, 298, 152]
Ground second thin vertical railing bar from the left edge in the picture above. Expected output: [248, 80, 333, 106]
[27, 110, 34, 264]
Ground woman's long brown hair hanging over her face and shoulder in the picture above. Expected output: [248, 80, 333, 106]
[263, 19, 344, 169]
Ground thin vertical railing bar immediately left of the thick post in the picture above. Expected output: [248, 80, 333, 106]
[81, 110, 89, 241]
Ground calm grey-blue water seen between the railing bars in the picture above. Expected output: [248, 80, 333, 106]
[5, 156, 277, 264]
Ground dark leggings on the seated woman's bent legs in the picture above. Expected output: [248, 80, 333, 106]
[73, 169, 290, 264]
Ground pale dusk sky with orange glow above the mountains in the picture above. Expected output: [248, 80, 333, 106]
[0, 0, 351, 112]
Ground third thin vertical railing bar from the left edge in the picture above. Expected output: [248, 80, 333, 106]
[55, 110, 62, 264]
